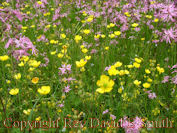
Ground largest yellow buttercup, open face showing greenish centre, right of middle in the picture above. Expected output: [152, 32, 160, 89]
[96, 75, 114, 93]
